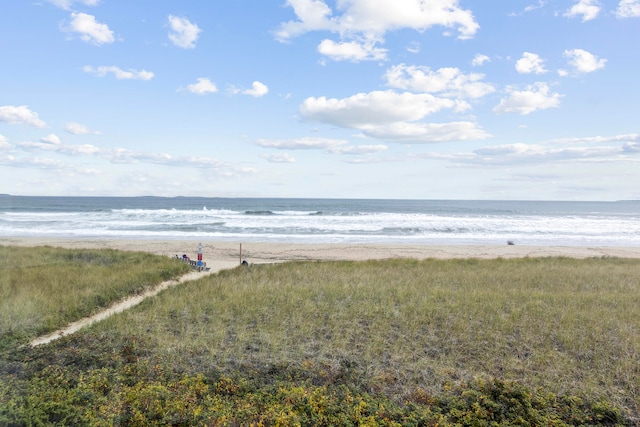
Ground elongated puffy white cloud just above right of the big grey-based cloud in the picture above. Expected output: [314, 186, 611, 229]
[385, 64, 495, 98]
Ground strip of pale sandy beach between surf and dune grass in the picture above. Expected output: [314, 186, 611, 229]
[0, 237, 640, 270]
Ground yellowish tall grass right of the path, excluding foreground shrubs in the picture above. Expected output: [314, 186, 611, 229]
[92, 258, 640, 413]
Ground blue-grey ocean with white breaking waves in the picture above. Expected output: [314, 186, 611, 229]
[0, 196, 640, 246]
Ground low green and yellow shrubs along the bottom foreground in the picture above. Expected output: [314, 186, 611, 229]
[0, 337, 631, 426]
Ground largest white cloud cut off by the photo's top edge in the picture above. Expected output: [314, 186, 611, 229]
[276, 0, 479, 41]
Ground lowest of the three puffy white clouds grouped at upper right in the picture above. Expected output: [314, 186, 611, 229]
[493, 83, 562, 115]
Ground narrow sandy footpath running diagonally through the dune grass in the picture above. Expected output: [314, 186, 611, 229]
[30, 266, 224, 347]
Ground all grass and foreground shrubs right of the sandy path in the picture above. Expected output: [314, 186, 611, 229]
[0, 249, 640, 426]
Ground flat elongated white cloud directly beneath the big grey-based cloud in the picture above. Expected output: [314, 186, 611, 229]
[362, 122, 491, 143]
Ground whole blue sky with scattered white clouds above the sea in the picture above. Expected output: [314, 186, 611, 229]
[0, 0, 640, 201]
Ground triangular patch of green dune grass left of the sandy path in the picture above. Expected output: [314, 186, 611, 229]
[0, 246, 189, 349]
